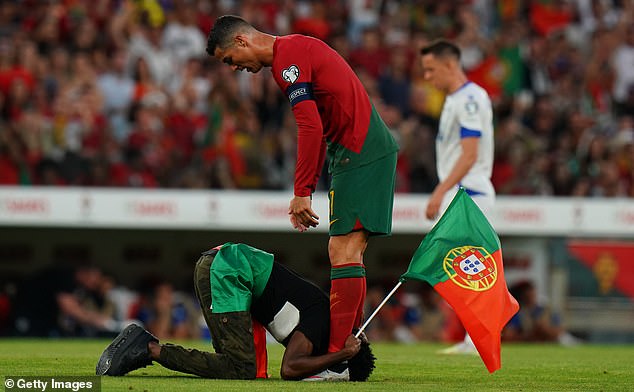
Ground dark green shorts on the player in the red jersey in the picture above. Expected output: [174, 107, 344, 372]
[328, 152, 397, 236]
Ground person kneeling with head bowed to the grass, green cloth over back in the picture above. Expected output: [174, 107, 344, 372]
[96, 243, 374, 381]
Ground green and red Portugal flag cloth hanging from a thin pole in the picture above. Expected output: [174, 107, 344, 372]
[400, 189, 519, 373]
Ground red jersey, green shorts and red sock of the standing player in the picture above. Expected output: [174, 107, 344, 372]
[271, 35, 398, 351]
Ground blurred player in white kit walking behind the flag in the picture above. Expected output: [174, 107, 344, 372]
[421, 40, 495, 353]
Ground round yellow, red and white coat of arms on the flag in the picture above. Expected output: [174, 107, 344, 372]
[443, 245, 498, 291]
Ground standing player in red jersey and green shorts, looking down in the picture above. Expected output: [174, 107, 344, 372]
[207, 15, 398, 358]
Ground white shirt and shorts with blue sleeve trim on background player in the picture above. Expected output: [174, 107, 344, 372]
[436, 82, 495, 214]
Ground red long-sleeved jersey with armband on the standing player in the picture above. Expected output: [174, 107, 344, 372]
[271, 35, 372, 196]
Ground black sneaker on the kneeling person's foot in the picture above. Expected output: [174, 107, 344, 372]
[96, 324, 158, 376]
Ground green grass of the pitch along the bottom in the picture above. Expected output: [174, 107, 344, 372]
[0, 339, 634, 392]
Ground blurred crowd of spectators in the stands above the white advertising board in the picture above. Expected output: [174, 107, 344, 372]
[0, 0, 634, 197]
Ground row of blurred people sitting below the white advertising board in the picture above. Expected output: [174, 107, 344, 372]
[0, 263, 578, 345]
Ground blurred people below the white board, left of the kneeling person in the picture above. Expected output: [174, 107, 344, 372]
[0, 263, 202, 339]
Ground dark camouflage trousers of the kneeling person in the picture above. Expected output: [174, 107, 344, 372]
[157, 253, 256, 379]
